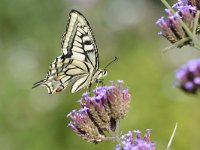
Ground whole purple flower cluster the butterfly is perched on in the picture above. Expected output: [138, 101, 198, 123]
[68, 80, 131, 143]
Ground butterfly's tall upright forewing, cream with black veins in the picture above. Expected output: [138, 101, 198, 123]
[61, 10, 99, 71]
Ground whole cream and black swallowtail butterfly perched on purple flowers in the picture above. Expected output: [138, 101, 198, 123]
[33, 10, 116, 94]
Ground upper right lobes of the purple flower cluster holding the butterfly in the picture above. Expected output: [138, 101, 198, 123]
[81, 80, 131, 130]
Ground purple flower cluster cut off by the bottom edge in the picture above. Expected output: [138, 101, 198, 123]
[116, 129, 155, 150]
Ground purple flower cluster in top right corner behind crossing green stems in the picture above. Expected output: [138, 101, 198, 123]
[156, 0, 200, 47]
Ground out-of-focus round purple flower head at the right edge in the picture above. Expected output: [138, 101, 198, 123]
[176, 59, 200, 94]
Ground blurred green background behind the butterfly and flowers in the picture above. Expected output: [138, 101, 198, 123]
[0, 0, 200, 150]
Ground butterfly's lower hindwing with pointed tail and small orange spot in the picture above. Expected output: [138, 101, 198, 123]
[33, 56, 92, 94]
